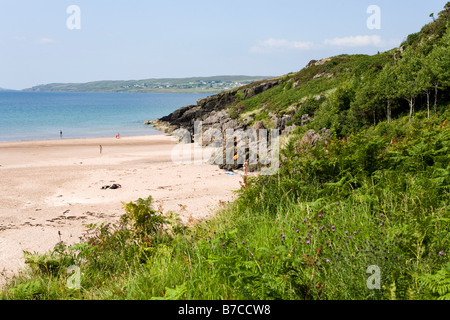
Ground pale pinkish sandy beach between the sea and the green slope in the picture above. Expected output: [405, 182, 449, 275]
[0, 135, 242, 286]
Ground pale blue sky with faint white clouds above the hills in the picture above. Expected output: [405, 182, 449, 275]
[0, 0, 448, 89]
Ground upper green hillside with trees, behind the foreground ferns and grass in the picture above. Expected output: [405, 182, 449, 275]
[228, 4, 450, 137]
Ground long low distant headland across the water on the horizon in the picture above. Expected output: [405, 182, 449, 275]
[23, 76, 270, 93]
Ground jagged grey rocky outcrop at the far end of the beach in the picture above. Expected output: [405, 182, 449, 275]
[145, 79, 323, 171]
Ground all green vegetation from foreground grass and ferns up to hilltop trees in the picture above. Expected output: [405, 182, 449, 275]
[0, 3, 450, 300]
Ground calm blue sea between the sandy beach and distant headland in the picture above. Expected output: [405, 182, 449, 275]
[0, 91, 209, 141]
